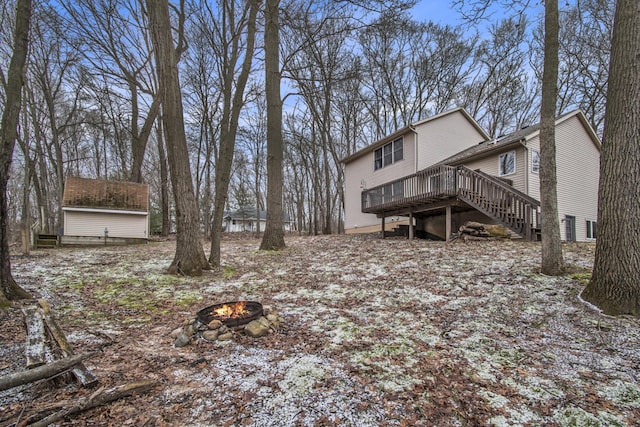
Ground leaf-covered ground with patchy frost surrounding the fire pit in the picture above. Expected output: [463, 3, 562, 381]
[0, 236, 640, 426]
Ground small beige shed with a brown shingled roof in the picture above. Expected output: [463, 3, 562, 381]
[61, 177, 149, 244]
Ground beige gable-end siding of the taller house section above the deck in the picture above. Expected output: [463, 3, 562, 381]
[416, 111, 485, 170]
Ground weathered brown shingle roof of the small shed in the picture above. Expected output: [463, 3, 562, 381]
[62, 176, 149, 212]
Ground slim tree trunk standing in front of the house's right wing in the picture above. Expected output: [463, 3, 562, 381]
[540, 0, 564, 276]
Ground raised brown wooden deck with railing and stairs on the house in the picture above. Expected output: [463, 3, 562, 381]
[362, 165, 540, 240]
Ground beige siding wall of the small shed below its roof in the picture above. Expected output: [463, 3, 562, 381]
[64, 210, 149, 239]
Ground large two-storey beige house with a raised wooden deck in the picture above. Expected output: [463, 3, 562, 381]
[343, 109, 600, 241]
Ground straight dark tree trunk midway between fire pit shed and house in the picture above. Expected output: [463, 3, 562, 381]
[260, 0, 285, 250]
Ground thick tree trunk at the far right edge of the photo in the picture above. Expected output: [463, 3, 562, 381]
[582, 0, 640, 317]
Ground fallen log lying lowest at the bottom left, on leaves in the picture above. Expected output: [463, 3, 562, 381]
[31, 380, 159, 427]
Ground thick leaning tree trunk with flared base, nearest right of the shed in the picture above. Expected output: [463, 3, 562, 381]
[147, 0, 211, 275]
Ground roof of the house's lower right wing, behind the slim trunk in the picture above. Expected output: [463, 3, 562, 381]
[438, 110, 601, 165]
